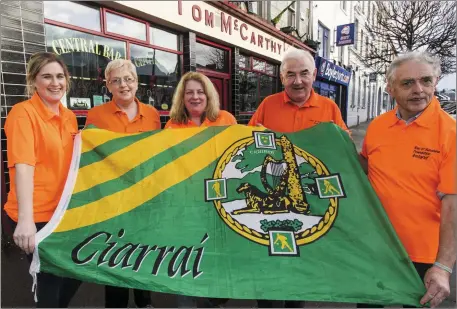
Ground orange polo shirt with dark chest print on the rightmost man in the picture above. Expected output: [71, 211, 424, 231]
[361, 98, 456, 263]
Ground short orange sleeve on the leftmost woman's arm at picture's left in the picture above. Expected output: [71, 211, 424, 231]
[5, 105, 36, 168]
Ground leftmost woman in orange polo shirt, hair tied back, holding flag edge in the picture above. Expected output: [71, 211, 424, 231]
[5, 53, 81, 308]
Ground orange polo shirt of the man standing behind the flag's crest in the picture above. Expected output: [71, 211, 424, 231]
[248, 90, 349, 133]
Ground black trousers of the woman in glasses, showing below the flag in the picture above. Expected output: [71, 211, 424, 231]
[105, 285, 151, 308]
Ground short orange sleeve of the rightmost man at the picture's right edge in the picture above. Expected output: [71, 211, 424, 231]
[436, 131, 457, 194]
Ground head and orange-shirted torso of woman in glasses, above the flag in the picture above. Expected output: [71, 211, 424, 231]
[86, 59, 160, 133]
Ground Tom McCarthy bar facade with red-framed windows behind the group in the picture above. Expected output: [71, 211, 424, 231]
[0, 1, 315, 190]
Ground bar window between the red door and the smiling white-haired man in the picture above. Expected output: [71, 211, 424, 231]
[240, 55, 278, 112]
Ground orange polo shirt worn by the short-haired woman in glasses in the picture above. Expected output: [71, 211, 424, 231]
[86, 98, 160, 133]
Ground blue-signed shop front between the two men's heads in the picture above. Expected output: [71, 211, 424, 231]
[313, 56, 351, 123]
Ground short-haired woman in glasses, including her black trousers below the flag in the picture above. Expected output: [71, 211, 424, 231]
[86, 59, 160, 308]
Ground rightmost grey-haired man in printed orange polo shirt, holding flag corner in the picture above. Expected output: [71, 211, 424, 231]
[361, 52, 457, 307]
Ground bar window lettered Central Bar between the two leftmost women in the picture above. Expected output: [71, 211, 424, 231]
[46, 25, 126, 110]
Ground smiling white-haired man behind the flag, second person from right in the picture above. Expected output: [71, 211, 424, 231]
[249, 48, 349, 133]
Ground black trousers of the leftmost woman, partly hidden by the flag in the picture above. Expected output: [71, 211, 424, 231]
[8, 217, 81, 308]
